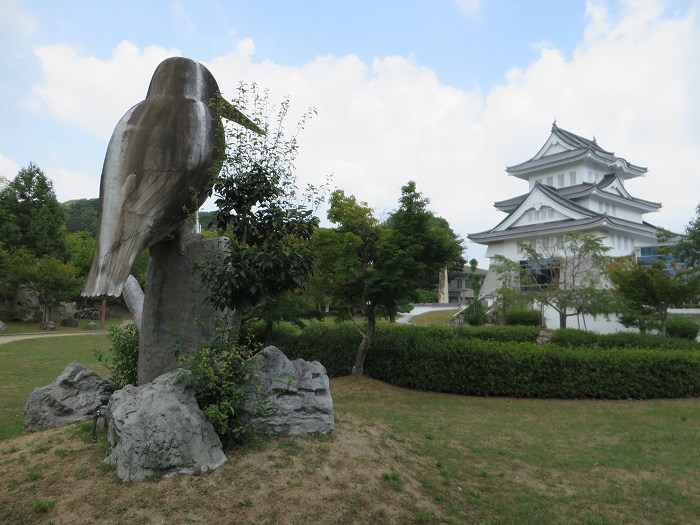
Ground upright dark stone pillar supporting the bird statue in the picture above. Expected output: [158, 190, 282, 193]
[138, 236, 231, 385]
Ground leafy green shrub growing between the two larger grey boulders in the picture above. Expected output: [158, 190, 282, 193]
[180, 338, 265, 448]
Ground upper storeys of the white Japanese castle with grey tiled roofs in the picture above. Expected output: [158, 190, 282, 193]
[469, 122, 661, 294]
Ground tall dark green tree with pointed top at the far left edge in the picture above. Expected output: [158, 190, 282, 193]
[0, 163, 68, 261]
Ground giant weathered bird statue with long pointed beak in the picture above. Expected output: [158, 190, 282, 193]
[82, 57, 264, 297]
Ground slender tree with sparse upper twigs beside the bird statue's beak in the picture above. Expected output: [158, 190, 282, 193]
[198, 85, 319, 333]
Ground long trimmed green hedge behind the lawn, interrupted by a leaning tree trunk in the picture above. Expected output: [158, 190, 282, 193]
[280, 323, 700, 399]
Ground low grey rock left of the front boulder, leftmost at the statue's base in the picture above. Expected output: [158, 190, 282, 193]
[24, 363, 114, 431]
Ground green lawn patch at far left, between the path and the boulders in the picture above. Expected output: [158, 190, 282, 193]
[0, 334, 109, 440]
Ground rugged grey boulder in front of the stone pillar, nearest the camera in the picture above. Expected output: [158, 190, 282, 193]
[105, 369, 226, 481]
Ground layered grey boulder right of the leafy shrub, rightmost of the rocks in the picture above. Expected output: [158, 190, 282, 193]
[246, 346, 335, 435]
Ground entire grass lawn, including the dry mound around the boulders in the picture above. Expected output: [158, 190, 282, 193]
[0, 336, 700, 525]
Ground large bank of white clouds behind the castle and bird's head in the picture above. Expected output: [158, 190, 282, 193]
[27, 1, 700, 264]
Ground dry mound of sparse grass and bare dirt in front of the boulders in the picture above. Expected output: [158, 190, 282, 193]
[0, 381, 439, 525]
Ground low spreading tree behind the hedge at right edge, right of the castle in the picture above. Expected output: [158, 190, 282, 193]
[608, 257, 700, 335]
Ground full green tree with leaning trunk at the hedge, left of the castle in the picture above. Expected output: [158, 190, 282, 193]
[313, 182, 464, 375]
